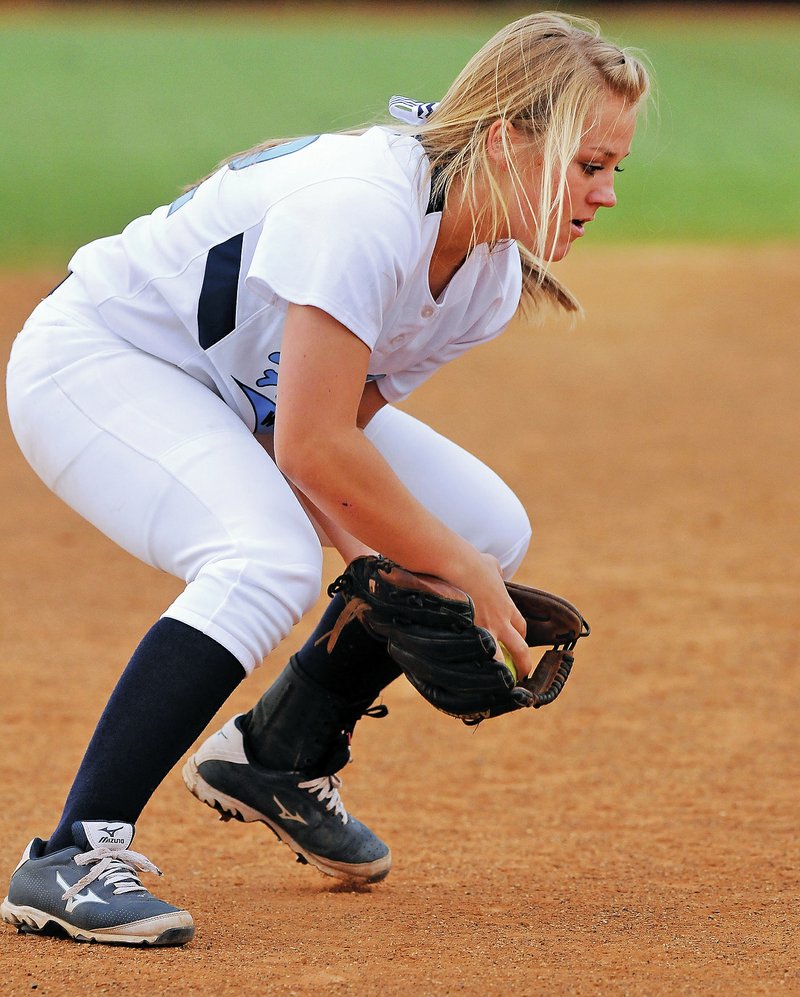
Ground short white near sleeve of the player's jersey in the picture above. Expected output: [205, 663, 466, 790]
[246, 178, 415, 349]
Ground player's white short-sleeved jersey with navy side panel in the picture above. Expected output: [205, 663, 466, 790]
[69, 128, 521, 432]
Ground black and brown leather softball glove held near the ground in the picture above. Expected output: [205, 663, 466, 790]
[328, 557, 589, 724]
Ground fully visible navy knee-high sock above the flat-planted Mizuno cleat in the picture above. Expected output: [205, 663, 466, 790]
[46, 618, 245, 852]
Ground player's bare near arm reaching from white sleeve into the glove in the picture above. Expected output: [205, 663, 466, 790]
[275, 305, 529, 671]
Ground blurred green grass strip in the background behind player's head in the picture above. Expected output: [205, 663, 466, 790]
[0, 5, 800, 266]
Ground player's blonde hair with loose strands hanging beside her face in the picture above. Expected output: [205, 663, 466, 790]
[414, 12, 649, 311]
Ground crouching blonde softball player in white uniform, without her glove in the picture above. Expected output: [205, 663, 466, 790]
[2, 14, 648, 945]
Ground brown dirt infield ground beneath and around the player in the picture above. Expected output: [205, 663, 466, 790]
[0, 247, 800, 995]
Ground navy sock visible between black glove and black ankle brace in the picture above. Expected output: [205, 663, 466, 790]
[295, 594, 401, 703]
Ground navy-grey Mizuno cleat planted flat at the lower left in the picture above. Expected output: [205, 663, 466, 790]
[0, 820, 194, 945]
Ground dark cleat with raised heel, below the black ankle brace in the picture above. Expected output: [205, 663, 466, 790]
[183, 714, 392, 883]
